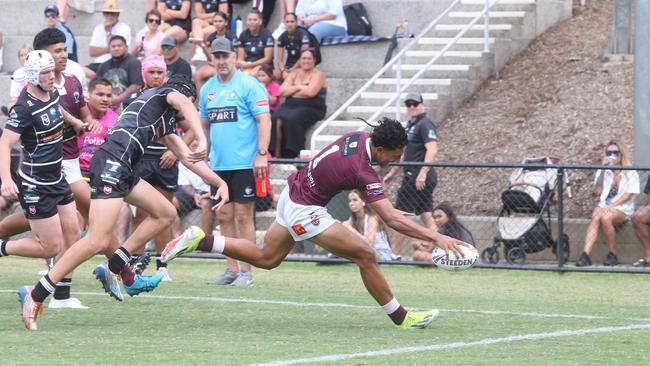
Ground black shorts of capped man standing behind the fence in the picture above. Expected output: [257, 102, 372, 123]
[395, 170, 438, 215]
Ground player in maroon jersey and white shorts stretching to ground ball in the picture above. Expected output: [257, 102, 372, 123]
[161, 118, 469, 329]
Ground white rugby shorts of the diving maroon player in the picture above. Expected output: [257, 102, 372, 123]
[275, 187, 336, 241]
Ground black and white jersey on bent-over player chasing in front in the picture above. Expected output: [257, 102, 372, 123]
[101, 86, 177, 166]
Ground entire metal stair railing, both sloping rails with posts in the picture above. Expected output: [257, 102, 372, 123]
[310, 0, 499, 150]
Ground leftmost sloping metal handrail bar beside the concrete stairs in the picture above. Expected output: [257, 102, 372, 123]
[310, 0, 460, 149]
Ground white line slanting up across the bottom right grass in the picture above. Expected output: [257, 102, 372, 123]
[251, 324, 650, 366]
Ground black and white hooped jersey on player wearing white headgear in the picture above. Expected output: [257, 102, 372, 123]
[5, 88, 63, 185]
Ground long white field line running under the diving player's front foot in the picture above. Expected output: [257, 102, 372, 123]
[0, 290, 650, 322]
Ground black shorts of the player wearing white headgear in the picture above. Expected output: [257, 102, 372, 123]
[18, 178, 74, 220]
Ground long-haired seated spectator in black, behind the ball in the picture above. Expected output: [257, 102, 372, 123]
[413, 202, 474, 261]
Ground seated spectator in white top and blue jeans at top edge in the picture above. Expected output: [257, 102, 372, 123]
[296, 0, 348, 42]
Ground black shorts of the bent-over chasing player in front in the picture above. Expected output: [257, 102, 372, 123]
[89, 149, 140, 199]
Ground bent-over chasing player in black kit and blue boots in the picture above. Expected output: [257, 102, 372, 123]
[16, 76, 228, 330]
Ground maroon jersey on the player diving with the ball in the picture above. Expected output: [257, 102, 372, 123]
[289, 132, 386, 206]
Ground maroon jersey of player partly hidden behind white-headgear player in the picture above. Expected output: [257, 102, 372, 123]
[54, 74, 86, 160]
